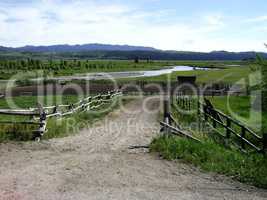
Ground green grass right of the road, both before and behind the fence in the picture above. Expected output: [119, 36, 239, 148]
[157, 96, 267, 188]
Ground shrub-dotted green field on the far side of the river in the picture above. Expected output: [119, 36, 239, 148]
[0, 60, 247, 79]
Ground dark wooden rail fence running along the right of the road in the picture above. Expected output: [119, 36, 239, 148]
[164, 94, 267, 153]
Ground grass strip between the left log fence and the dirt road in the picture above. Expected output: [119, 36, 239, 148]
[0, 98, 130, 142]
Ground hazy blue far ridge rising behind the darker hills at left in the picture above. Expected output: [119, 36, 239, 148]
[0, 44, 157, 52]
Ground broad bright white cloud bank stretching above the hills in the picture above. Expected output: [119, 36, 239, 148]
[0, 0, 264, 51]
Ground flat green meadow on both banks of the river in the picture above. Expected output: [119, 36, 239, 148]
[0, 60, 253, 88]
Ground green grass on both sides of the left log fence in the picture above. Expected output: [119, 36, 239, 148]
[0, 96, 129, 142]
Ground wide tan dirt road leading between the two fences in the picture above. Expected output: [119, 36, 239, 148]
[0, 96, 267, 200]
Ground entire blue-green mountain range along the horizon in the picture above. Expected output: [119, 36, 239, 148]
[0, 44, 267, 60]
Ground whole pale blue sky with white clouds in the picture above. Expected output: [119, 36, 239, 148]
[0, 0, 267, 52]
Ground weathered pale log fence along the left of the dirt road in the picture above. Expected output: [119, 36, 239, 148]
[0, 91, 122, 140]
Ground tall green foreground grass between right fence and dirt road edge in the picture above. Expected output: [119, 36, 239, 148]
[150, 137, 267, 188]
